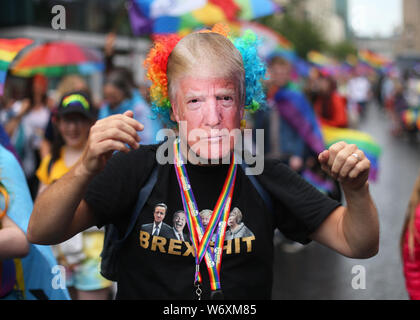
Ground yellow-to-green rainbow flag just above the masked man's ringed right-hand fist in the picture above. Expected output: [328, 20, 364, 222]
[322, 125, 382, 181]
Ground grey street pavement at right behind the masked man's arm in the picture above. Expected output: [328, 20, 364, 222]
[272, 104, 420, 300]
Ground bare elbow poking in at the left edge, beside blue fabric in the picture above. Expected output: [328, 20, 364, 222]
[0, 216, 29, 261]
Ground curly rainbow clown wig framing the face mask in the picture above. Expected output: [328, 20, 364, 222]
[144, 24, 266, 127]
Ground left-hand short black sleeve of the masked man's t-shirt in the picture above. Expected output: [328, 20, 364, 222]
[84, 146, 155, 228]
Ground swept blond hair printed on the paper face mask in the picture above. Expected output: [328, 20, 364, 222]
[167, 32, 245, 106]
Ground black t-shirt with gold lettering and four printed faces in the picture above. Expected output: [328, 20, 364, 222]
[85, 145, 340, 299]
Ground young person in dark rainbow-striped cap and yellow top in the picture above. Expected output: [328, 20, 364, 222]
[36, 91, 111, 299]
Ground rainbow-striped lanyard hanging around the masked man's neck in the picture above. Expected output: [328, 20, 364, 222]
[174, 138, 236, 296]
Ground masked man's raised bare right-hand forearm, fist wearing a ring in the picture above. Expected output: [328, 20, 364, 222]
[311, 142, 379, 259]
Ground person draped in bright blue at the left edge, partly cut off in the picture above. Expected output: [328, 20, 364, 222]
[0, 143, 70, 300]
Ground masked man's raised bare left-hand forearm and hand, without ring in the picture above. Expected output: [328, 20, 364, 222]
[27, 111, 143, 244]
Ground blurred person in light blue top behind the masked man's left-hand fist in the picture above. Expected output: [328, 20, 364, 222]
[98, 67, 161, 144]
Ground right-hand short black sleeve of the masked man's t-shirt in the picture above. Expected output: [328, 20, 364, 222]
[259, 161, 341, 244]
